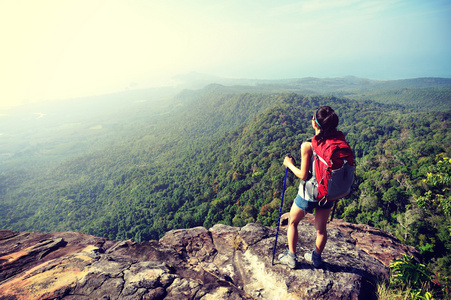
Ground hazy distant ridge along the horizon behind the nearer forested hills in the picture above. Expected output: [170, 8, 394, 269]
[171, 74, 451, 111]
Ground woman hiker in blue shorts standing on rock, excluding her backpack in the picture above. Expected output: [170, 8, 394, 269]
[279, 106, 342, 269]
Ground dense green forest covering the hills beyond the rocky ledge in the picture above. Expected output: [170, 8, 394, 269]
[0, 77, 451, 298]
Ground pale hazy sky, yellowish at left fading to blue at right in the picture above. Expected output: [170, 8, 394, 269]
[0, 0, 451, 107]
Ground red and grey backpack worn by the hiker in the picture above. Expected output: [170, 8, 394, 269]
[312, 131, 355, 202]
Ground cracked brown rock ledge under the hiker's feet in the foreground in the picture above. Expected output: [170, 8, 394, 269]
[0, 216, 417, 300]
